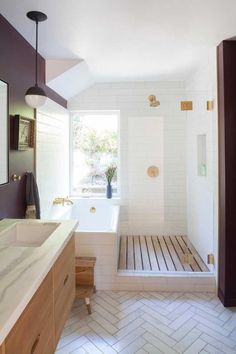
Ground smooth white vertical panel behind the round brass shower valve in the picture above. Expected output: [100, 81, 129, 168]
[127, 117, 164, 235]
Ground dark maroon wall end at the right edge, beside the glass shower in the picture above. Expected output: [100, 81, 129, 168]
[218, 41, 236, 306]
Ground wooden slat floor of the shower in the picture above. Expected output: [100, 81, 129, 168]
[119, 236, 209, 272]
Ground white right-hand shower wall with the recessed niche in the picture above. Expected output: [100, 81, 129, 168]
[186, 52, 218, 272]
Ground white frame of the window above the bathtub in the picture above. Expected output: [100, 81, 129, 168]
[69, 109, 120, 199]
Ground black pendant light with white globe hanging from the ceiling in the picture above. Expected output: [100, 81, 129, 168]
[25, 11, 47, 108]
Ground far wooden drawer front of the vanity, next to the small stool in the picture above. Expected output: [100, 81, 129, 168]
[54, 237, 75, 342]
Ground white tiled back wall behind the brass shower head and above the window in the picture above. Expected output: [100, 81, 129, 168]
[68, 82, 187, 234]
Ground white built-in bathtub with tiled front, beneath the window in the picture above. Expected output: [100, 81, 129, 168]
[50, 199, 120, 289]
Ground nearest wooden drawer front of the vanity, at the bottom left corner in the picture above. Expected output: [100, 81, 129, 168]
[5, 271, 55, 354]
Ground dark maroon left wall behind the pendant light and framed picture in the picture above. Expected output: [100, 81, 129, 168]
[0, 14, 67, 218]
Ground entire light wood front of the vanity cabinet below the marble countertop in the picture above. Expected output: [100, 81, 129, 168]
[0, 236, 75, 354]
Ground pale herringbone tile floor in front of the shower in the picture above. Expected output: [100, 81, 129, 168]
[56, 291, 236, 354]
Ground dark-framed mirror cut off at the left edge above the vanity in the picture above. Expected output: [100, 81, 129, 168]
[0, 80, 9, 185]
